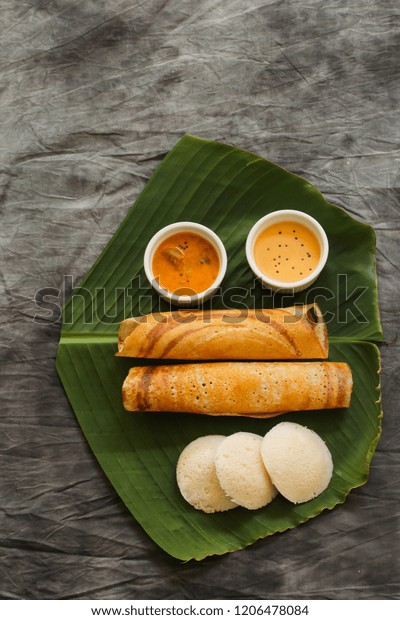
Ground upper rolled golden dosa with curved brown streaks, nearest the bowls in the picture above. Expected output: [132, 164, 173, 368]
[117, 304, 329, 360]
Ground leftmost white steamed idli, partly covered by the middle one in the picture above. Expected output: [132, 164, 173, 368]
[176, 435, 237, 512]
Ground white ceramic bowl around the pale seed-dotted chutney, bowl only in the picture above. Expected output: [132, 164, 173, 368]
[246, 209, 329, 293]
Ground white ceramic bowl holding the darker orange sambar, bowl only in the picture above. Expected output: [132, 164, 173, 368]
[144, 222, 228, 306]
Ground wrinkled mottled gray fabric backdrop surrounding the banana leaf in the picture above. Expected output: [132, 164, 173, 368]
[0, 0, 400, 599]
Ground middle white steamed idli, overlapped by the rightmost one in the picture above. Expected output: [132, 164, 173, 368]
[215, 432, 277, 510]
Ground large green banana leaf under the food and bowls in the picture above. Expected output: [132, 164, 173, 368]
[57, 136, 382, 560]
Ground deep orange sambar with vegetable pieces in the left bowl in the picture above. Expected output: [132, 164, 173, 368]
[152, 232, 220, 295]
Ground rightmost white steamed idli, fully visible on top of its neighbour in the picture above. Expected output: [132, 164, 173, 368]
[261, 422, 333, 504]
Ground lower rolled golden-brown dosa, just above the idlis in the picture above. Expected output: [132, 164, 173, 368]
[122, 362, 352, 418]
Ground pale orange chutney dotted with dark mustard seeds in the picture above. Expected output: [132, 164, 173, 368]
[254, 222, 321, 282]
